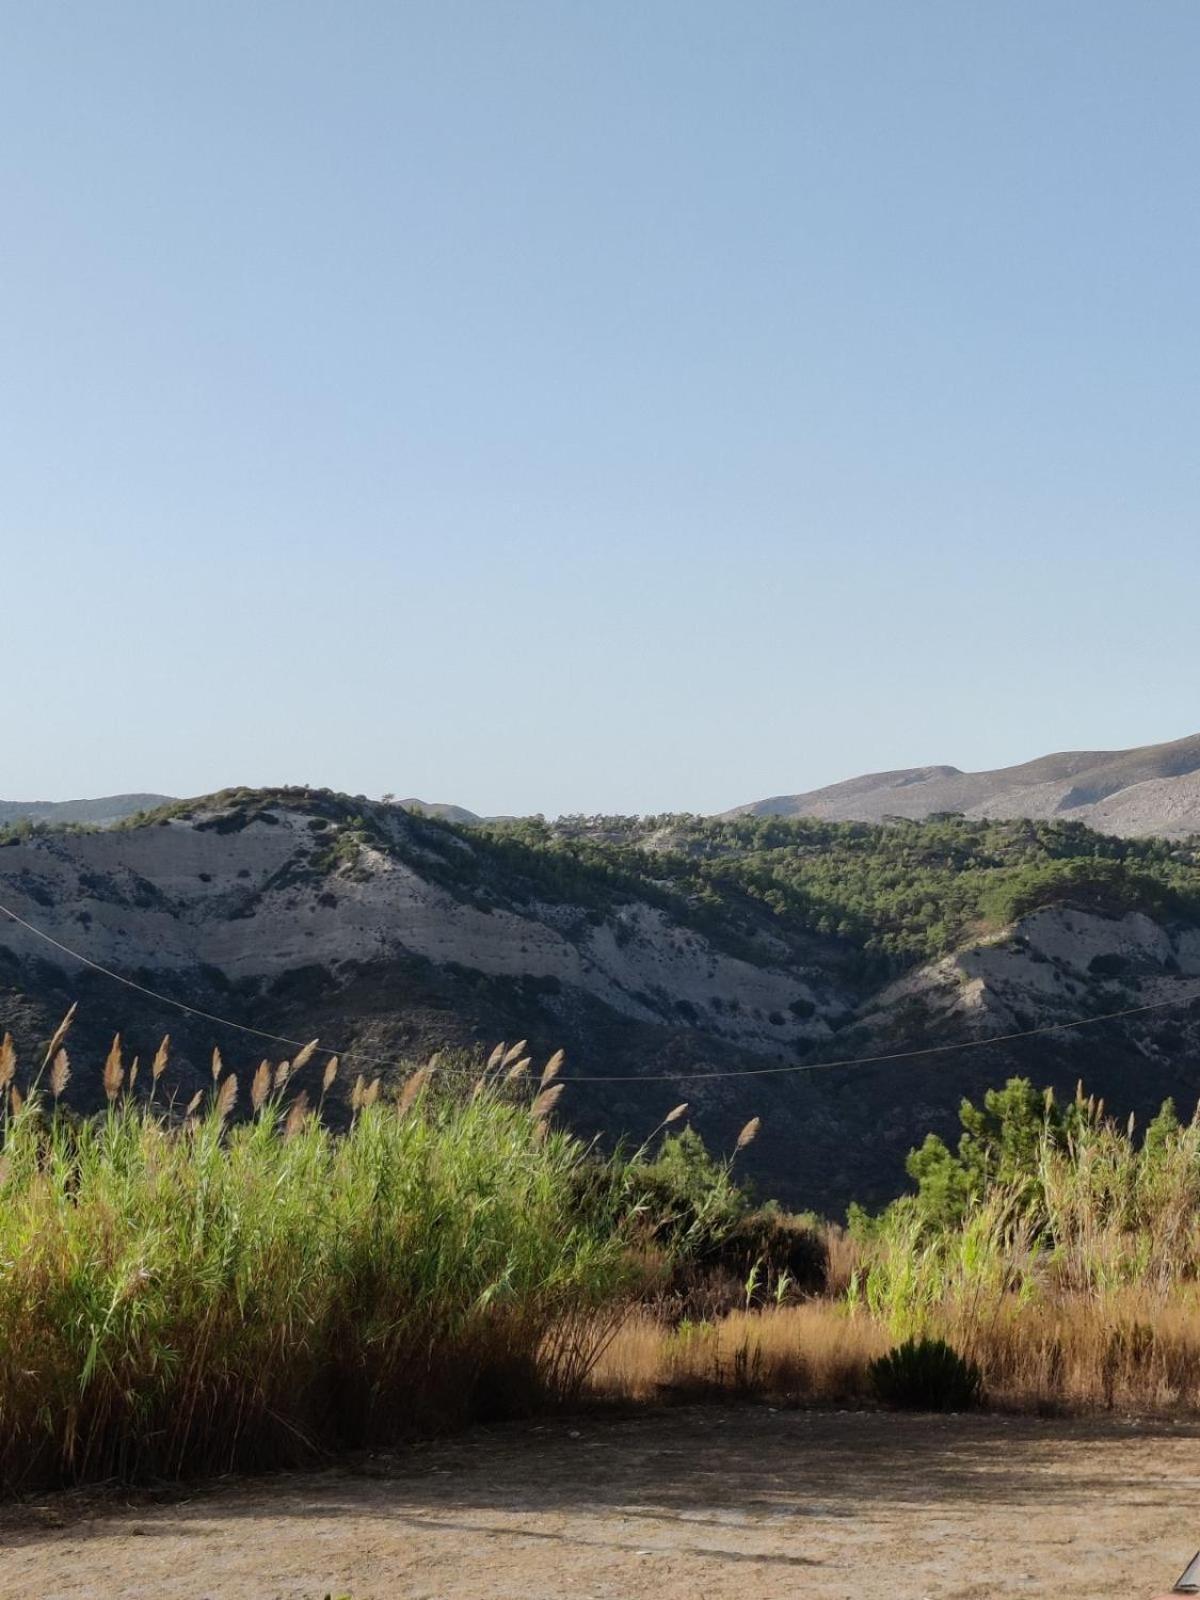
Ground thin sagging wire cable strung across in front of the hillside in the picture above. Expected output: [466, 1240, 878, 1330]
[9, 904, 1197, 1083]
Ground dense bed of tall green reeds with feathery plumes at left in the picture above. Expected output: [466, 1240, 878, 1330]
[0, 1046, 640, 1488]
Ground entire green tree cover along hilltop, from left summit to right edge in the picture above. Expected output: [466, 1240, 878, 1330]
[91, 789, 1200, 971]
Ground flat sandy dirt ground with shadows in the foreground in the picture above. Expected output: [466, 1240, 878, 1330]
[0, 1406, 1200, 1600]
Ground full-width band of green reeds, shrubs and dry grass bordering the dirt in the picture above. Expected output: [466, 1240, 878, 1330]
[9, 1024, 1200, 1490]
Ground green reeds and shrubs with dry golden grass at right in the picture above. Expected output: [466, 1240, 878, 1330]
[595, 1078, 1200, 1413]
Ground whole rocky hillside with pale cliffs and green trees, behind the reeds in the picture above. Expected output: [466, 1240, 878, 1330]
[0, 790, 1200, 1210]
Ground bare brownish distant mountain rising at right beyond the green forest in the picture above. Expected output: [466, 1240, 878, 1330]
[725, 734, 1200, 838]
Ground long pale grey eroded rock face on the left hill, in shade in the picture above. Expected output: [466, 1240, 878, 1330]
[0, 810, 848, 1051]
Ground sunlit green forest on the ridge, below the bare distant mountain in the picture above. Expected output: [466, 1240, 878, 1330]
[466, 816, 1200, 965]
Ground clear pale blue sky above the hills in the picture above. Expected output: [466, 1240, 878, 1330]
[0, 0, 1200, 814]
